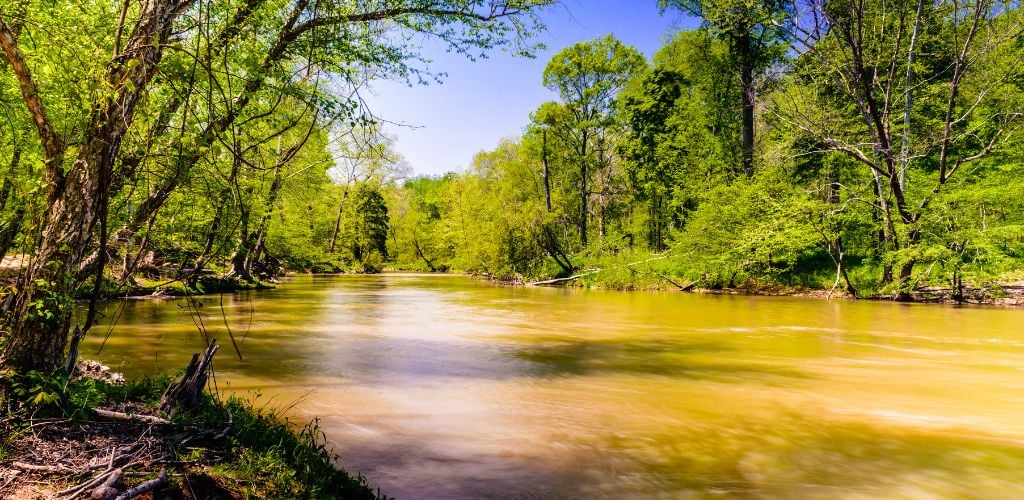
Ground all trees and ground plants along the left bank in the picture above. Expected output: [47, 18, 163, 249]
[0, 0, 551, 498]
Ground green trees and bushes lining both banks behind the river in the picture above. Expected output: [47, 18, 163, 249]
[0, 0, 1024, 497]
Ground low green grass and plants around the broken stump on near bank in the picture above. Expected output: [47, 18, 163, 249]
[0, 372, 386, 499]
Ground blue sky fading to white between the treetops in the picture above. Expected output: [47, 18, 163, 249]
[364, 0, 698, 175]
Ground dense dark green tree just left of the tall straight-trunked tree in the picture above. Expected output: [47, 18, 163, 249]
[618, 31, 738, 251]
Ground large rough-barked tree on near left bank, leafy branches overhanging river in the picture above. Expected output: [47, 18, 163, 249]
[0, 0, 548, 372]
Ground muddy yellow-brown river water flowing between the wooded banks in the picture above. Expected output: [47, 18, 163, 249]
[83, 275, 1024, 498]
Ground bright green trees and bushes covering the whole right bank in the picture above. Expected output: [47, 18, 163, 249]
[380, 1, 1024, 296]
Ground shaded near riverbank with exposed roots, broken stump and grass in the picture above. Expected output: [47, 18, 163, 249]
[0, 377, 381, 499]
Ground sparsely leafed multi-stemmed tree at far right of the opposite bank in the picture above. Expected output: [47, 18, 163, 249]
[771, 0, 1024, 296]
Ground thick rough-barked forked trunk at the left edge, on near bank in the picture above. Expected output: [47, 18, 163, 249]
[0, 0, 180, 373]
